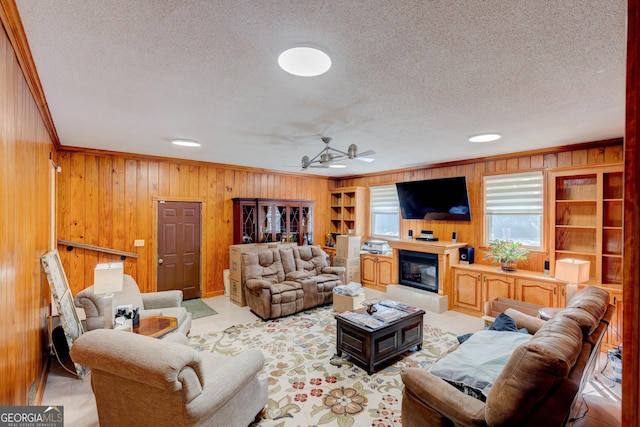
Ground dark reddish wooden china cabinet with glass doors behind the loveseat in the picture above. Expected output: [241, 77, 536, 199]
[233, 198, 313, 245]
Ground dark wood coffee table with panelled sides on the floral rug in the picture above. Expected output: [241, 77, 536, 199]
[336, 307, 424, 374]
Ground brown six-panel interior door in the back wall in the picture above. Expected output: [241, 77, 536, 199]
[157, 201, 202, 299]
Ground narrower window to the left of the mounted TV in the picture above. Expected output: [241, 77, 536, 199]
[369, 184, 400, 237]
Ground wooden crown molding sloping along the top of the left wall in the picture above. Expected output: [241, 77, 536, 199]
[0, 0, 60, 149]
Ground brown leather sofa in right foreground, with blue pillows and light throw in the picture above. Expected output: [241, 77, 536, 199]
[401, 286, 615, 427]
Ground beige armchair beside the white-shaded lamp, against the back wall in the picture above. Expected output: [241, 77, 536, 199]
[73, 274, 191, 335]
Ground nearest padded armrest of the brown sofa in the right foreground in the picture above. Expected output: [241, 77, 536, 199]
[401, 368, 486, 426]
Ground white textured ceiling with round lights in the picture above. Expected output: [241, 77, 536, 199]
[16, 0, 627, 176]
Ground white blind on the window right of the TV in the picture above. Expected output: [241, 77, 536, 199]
[484, 172, 543, 215]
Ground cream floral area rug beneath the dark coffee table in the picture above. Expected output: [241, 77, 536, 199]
[189, 306, 457, 427]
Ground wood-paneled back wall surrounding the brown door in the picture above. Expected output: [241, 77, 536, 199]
[57, 150, 329, 297]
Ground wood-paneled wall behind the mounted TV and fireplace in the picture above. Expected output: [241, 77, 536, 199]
[331, 140, 623, 271]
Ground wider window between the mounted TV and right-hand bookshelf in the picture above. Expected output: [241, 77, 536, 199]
[484, 171, 544, 248]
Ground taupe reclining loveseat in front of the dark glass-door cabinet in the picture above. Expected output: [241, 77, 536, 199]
[242, 246, 345, 320]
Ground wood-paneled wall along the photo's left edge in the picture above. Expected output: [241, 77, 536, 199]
[0, 22, 55, 405]
